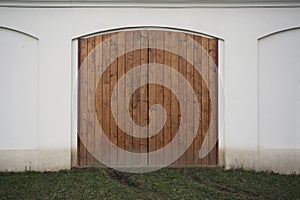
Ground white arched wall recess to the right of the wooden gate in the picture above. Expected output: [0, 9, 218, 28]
[258, 27, 300, 148]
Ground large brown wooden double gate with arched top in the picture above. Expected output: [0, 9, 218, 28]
[78, 29, 218, 166]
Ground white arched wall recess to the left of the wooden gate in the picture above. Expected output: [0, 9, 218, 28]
[0, 27, 38, 149]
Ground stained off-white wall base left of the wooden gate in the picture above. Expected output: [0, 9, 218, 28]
[0, 149, 71, 171]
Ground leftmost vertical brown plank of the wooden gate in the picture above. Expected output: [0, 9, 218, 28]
[78, 39, 88, 165]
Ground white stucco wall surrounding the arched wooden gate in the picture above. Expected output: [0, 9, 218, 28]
[0, 1, 300, 173]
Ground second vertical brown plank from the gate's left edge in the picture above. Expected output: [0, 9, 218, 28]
[86, 37, 95, 165]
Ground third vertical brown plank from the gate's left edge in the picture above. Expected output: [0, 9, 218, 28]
[95, 35, 103, 166]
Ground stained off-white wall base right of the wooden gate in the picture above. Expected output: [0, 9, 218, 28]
[225, 149, 300, 174]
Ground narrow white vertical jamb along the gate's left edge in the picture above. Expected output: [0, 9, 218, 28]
[71, 39, 78, 166]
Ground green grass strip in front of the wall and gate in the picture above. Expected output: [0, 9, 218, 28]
[0, 168, 300, 199]
